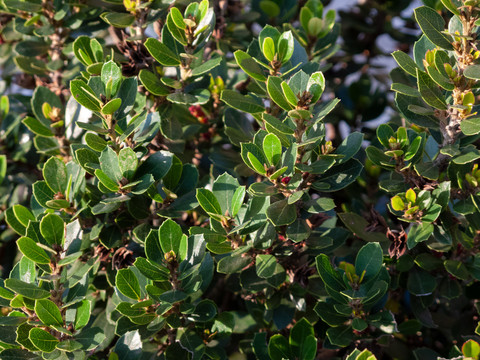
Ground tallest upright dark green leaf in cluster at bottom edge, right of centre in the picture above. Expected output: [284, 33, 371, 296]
[290, 318, 317, 360]
